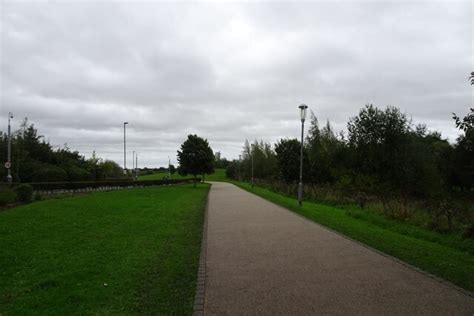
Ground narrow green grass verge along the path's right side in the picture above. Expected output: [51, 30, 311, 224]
[228, 180, 474, 292]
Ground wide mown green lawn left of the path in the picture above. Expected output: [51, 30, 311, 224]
[0, 184, 209, 315]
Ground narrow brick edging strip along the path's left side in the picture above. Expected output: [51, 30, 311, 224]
[193, 184, 212, 316]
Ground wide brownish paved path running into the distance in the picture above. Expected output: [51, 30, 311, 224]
[204, 183, 474, 316]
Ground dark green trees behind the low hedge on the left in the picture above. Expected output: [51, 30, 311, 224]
[0, 119, 124, 183]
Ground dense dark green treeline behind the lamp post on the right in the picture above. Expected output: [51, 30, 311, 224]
[226, 105, 474, 233]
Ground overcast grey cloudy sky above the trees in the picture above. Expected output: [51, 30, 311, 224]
[0, 0, 474, 167]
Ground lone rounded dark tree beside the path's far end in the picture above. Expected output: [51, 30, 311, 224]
[178, 135, 214, 187]
